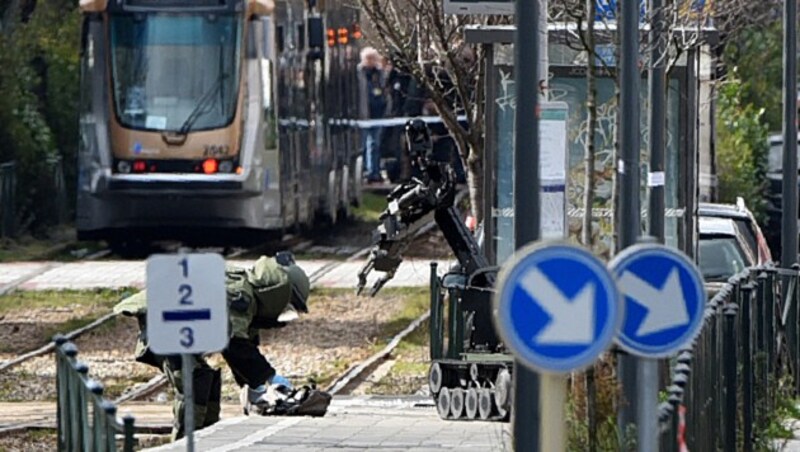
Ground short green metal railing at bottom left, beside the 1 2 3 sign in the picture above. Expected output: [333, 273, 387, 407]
[54, 336, 134, 452]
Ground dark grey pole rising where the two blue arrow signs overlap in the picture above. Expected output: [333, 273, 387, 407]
[617, 0, 641, 439]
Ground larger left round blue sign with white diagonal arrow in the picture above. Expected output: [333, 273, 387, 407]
[494, 244, 622, 373]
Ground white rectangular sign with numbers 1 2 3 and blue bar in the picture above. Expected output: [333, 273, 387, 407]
[147, 254, 228, 355]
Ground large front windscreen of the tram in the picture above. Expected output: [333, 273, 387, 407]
[110, 13, 241, 133]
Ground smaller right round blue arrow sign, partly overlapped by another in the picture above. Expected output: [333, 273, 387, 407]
[610, 244, 706, 358]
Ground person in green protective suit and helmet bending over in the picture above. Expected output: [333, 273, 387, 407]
[114, 253, 310, 440]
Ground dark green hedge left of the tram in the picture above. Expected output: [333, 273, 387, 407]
[0, 0, 80, 233]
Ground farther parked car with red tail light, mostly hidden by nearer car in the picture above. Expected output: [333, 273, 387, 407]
[697, 198, 773, 265]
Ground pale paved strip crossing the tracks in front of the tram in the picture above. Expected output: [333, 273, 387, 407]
[0, 259, 450, 293]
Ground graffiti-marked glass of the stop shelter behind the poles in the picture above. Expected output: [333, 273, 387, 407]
[489, 45, 689, 263]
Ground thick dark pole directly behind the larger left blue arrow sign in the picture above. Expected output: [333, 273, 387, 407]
[512, 0, 546, 452]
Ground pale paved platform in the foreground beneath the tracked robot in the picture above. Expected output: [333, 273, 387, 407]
[148, 397, 511, 452]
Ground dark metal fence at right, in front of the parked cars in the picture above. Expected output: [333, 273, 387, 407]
[658, 267, 800, 451]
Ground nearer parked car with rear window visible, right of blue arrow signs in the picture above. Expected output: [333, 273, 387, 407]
[697, 216, 757, 297]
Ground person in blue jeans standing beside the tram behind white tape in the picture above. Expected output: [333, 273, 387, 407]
[358, 47, 389, 182]
